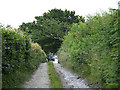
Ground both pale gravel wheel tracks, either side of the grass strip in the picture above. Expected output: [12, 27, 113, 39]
[24, 58, 89, 88]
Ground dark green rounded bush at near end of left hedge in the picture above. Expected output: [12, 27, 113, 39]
[2, 28, 31, 74]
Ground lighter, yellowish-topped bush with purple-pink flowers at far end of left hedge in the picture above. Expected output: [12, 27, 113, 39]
[27, 42, 47, 69]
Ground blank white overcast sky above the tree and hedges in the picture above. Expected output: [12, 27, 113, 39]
[0, 0, 120, 28]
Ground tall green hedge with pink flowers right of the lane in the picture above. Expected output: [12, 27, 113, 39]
[58, 9, 120, 88]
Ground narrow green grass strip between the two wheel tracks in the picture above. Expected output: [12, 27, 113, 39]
[48, 62, 62, 88]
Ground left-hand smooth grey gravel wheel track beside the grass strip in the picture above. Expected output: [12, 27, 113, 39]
[24, 63, 50, 88]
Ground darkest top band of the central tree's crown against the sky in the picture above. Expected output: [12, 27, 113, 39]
[42, 8, 85, 24]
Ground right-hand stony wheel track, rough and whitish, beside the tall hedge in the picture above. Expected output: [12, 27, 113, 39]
[54, 63, 89, 88]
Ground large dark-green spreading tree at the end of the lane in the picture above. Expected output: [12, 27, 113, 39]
[20, 9, 85, 54]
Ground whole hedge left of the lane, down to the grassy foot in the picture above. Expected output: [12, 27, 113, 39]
[1, 28, 46, 88]
